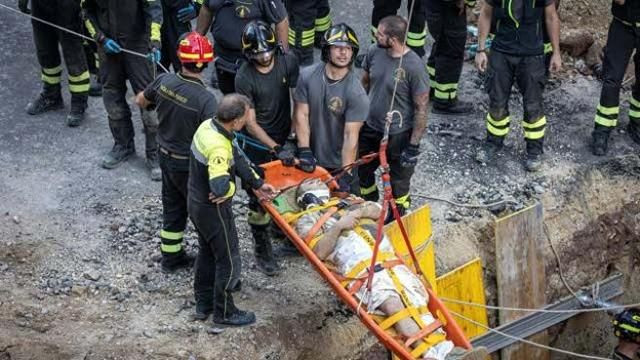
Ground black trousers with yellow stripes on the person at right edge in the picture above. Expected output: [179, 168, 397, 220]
[595, 19, 640, 133]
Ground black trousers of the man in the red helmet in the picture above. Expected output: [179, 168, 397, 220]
[159, 152, 189, 256]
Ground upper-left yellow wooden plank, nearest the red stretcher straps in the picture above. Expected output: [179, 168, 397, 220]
[385, 205, 436, 290]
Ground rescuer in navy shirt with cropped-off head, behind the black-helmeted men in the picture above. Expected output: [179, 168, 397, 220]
[196, 0, 289, 94]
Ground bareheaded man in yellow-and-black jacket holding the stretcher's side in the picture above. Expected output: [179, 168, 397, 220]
[188, 94, 275, 325]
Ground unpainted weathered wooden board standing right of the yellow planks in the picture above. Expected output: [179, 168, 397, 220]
[495, 203, 549, 360]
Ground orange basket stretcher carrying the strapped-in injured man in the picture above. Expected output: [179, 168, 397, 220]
[261, 161, 471, 360]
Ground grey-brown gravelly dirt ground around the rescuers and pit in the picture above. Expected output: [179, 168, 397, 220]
[0, 0, 640, 360]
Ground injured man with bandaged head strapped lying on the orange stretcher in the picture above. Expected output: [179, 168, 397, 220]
[295, 180, 488, 360]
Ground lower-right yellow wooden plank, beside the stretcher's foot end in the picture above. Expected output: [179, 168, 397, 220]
[436, 258, 489, 338]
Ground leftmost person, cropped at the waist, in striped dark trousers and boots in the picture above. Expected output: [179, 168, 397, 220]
[18, 0, 90, 127]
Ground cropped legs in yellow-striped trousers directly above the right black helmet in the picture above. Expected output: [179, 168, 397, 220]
[285, 0, 331, 66]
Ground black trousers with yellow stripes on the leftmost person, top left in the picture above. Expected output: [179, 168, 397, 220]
[31, 0, 90, 97]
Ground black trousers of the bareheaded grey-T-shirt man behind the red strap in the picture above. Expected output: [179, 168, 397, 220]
[358, 124, 415, 210]
